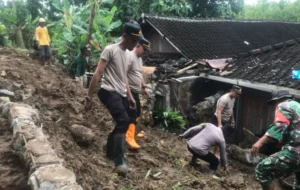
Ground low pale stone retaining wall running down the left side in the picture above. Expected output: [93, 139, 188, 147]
[0, 99, 82, 190]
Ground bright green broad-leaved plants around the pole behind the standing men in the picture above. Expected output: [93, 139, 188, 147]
[47, 0, 122, 77]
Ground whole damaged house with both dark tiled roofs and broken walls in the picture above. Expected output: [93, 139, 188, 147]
[140, 15, 300, 142]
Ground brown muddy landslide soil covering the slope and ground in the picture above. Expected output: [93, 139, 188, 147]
[0, 46, 278, 190]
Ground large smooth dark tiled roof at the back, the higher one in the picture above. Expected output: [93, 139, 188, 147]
[143, 15, 300, 59]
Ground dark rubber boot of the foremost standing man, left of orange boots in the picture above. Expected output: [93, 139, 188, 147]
[114, 134, 132, 173]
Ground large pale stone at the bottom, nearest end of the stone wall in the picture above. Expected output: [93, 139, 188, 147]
[29, 164, 76, 190]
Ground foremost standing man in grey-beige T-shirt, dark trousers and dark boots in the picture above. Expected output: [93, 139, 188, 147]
[85, 22, 142, 172]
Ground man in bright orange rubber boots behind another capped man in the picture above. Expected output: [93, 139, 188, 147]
[126, 39, 151, 149]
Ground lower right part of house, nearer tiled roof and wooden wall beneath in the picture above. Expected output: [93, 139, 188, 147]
[205, 38, 300, 142]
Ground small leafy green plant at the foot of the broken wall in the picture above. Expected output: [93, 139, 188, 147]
[154, 111, 186, 132]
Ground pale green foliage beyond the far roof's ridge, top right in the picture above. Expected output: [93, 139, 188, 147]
[237, 0, 300, 22]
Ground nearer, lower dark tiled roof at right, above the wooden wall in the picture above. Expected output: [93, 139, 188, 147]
[218, 40, 300, 90]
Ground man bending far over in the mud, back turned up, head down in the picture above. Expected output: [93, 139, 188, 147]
[178, 123, 229, 174]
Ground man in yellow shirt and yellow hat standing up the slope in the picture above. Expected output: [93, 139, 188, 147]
[35, 18, 51, 65]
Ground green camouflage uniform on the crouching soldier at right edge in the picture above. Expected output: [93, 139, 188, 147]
[255, 100, 300, 185]
